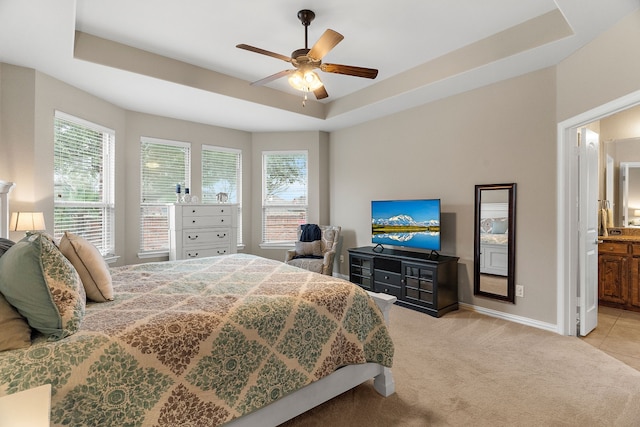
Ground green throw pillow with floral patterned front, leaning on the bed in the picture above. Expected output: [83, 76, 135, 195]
[0, 233, 86, 339]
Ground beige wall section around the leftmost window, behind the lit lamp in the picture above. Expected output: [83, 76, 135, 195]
[0, 64, 126, 246]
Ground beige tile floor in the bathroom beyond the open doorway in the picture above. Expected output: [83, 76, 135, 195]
[582, 307, 640, 371]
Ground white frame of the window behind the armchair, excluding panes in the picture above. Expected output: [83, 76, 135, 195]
[260, 150, 309, 249]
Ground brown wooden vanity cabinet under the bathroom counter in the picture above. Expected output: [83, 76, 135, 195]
[598, 240, 640, 311]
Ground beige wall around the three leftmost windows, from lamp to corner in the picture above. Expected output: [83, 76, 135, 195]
[0, 64, 252, 265]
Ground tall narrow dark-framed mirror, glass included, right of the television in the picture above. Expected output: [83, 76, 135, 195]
[473, 183, 516, 303]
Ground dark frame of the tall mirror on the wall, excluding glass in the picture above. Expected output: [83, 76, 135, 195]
[473, 183, 516, 304]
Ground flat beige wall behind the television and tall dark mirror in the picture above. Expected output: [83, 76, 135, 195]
[330, 68, 556, 323]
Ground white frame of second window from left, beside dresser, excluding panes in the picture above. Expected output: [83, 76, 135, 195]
[138, 136, 191, 258]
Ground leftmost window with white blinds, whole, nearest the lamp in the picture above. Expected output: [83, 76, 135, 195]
[53, 111, 115, 257]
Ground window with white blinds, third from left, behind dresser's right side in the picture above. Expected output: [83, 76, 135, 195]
[202, 145, 242, 245]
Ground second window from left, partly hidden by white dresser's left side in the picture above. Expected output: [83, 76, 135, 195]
[140, 138, 191, 256]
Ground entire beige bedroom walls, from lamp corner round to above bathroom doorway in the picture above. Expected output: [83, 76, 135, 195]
[0, 5, 640, 324]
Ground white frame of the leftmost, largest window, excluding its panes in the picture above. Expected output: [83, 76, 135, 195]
[53, 110, 117, 261]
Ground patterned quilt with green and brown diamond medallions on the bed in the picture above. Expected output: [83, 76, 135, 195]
[0, 254, 393, 426]
